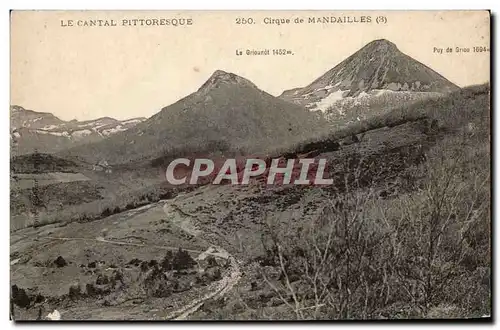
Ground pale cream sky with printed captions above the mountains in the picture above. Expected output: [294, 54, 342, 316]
[11, 11, 490, 120]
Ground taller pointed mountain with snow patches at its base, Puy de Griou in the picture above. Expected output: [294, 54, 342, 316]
[280, 39, 459, 114]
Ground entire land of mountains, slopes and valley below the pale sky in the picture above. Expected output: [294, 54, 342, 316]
[10, 40, 491, 321]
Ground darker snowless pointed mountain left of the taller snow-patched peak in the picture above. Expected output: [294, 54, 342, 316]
[61, 70, 326, 163]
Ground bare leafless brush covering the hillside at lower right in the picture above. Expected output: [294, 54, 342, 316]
[260, 86, 491, 319]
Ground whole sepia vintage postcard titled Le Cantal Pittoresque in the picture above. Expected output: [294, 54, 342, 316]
[10, 11, 492, 321]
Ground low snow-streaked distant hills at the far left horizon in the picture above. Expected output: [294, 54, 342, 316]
[10, 105, 145, 155]
